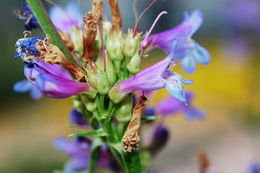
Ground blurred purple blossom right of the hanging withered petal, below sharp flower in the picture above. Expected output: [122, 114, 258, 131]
[145, 92, 205, 120]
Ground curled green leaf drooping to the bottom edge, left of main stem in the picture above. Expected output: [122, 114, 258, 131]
[88, 138, 103, 173]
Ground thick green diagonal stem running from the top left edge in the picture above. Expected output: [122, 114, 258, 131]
[26, 0, 75, 64]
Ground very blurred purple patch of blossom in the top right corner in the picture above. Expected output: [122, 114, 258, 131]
[225, 0, 260, 33]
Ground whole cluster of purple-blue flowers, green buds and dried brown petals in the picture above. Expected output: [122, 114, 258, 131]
[14, 0, 210, 173]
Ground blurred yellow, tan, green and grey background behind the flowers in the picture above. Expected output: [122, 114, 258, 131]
[0, 0, 260, 173]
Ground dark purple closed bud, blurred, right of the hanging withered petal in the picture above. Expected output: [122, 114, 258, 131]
[148, 124, 169, 154]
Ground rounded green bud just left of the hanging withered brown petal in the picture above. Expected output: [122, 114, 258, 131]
[115, 97, 133, 123]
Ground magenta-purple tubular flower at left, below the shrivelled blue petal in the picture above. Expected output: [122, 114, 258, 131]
[24, 61, 89, 98]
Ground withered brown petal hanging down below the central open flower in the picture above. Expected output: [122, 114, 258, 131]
[122, 96, 147, 152]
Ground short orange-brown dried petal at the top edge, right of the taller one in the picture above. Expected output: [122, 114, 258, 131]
[108, 0, 122, 30]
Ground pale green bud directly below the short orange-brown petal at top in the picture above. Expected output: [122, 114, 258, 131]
[105, 31, 124, 60]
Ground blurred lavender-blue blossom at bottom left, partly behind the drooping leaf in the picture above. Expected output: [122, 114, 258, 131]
[54, 137, 111, 173]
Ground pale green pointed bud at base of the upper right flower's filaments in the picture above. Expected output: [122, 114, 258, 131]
[124, 30, 141, 57]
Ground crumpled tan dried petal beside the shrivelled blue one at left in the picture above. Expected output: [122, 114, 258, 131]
[35, 36, 85, 81]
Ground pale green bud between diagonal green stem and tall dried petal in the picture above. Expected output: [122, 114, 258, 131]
[70, 26, 83, 56]
